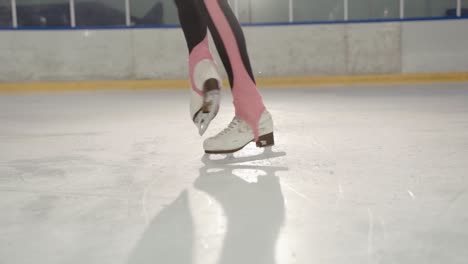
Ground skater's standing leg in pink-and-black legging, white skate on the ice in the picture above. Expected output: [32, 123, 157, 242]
[198, 0, 274, 153]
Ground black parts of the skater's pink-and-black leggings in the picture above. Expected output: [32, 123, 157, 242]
[175, 0, 255, 87]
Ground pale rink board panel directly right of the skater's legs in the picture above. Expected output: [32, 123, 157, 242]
[245, 25, 346, 77]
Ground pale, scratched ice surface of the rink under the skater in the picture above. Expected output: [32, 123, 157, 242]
[0, 83, 468, 264]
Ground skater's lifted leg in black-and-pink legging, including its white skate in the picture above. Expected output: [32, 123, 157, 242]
[175, 0, 221, 135]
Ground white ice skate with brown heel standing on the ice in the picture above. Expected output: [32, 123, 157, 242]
[203, 111, 275, 154]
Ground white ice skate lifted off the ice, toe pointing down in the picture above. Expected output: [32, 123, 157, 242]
[190, 59, 222, 135]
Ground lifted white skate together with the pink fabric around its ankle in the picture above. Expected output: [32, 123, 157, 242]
[189, 36, 222, 135]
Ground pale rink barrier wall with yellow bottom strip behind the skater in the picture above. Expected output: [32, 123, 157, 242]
[0, 19, 468, 90]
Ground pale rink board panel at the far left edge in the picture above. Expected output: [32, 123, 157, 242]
[0, 30, 133, 82]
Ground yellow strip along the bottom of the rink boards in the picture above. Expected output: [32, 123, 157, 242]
[0, 72, 468, 93]
